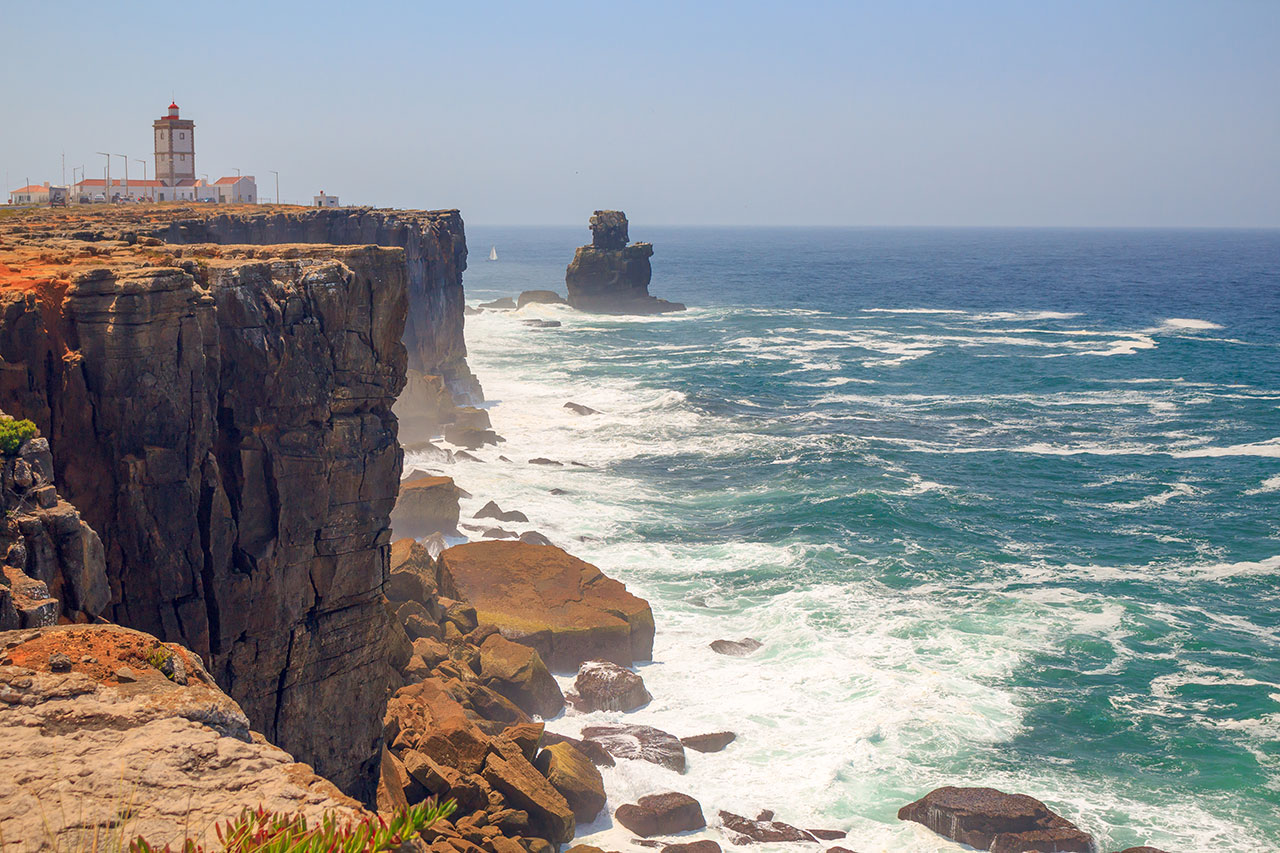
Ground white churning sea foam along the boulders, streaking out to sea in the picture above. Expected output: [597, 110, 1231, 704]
[448, 302, 1280, 853]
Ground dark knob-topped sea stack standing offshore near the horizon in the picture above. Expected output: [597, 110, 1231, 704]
[564, 210, 685, 314]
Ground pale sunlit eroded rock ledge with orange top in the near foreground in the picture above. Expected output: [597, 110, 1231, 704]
[0, 625, 362, 853]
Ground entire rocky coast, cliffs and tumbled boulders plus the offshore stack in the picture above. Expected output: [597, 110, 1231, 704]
[0, 206, 1172, 853]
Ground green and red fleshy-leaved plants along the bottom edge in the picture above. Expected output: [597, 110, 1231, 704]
[129, 799, 457, 853]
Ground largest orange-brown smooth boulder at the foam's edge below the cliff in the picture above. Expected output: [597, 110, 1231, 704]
[439, 542, 653, 670]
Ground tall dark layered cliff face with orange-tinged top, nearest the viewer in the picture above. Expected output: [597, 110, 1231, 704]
[0, 216, 414, 798]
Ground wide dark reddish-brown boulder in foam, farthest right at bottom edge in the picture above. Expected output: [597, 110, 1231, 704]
[897, 786, 1093, 853]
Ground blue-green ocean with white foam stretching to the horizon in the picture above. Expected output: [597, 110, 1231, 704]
[406, 223, 1280, 853]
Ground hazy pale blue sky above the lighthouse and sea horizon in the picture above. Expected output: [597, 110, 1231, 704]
[0, 0, 1280, 227]
